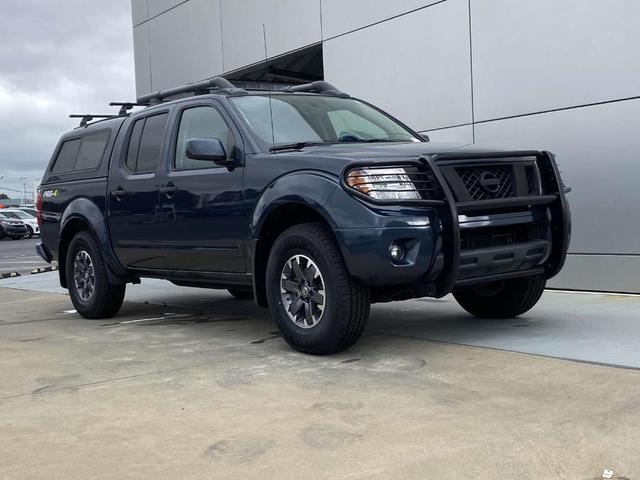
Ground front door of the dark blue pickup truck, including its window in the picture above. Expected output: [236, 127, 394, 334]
[160, 100, 249, 273]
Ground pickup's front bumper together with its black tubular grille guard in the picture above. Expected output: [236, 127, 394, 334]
[335, 152, 571, 297]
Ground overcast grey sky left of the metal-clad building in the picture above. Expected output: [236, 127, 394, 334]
[0, 0, 135, 198]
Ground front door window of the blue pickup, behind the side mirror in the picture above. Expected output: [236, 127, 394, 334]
[173, 107, 236, 170]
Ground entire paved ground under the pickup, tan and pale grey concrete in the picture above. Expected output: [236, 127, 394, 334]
[0, 273, 640, 480]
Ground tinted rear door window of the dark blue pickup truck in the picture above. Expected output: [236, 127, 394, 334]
[125, 113, 169, 173]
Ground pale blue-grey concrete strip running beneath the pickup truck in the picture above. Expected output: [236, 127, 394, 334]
[5, 272, 640, 368]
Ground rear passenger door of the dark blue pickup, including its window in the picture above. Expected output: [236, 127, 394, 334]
[109, 110, 169, 269]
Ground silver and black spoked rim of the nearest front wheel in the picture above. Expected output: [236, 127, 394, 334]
[280, 255, 327, 328]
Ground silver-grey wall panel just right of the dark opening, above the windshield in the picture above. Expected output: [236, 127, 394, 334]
[323, 0, 471, 130]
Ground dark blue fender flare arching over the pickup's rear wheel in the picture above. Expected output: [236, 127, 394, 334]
[58, 198, 127, 280]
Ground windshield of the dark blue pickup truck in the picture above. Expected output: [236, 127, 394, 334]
[232, 94, 421, 145]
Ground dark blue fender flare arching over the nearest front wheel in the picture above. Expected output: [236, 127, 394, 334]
[251, 172, 340, 240]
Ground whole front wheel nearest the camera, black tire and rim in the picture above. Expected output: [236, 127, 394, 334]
[266, 223, 371, 355]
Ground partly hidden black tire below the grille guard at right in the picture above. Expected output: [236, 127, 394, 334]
[453, 277, 547, 318]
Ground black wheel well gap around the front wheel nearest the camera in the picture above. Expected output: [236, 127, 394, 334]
[253, 203, 330, 307]
